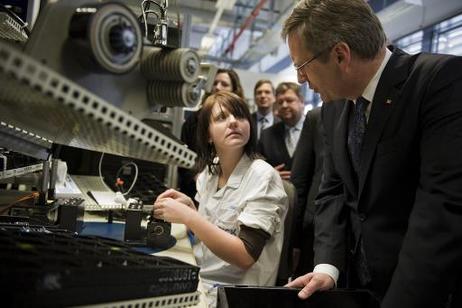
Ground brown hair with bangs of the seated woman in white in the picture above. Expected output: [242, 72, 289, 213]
[197, 91, 259, 174]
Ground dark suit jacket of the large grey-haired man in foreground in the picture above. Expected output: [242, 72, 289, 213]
[315, 46, 462, 307]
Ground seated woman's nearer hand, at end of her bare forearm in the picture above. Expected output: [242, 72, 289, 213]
[153, 198, 198, 225]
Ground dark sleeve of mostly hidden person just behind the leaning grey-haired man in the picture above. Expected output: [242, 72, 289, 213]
[290, 112, 317, 248]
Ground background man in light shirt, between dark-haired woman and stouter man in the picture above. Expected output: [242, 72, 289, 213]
[252, 79, 279, 142]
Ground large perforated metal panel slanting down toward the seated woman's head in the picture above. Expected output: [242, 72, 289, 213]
[0, 41, 196, 168]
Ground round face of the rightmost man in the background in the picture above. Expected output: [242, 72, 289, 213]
[276, 89, 305, 126]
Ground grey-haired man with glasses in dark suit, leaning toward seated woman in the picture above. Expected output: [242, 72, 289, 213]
[282, 0, 462, 308]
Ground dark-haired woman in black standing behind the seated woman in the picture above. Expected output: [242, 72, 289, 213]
[178, 68, 244, 198]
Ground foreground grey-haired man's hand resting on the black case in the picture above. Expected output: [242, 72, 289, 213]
[286, 273, 335, 299]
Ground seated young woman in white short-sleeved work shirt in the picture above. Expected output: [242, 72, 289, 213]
[154, 91, 288, 307]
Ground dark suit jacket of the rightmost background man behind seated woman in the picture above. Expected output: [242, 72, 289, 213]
[257, 121, 292, 170]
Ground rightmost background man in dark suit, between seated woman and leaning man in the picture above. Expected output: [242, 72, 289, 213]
[257, 82, 305, 180]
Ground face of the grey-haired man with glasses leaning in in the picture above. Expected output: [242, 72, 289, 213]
[287, 32, 342, 102]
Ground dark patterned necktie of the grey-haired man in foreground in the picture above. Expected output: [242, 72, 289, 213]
[348, 96, 369, 173]
